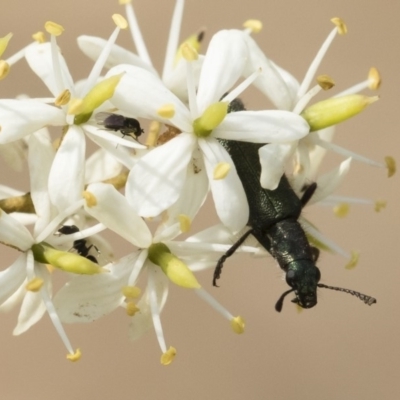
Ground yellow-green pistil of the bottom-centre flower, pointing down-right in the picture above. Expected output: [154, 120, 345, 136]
[148, 243, 201, 289]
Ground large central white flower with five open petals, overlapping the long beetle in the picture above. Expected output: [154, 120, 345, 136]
[108, 31, 309, 232]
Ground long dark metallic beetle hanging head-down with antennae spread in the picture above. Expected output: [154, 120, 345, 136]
[213, 99, 376, 312]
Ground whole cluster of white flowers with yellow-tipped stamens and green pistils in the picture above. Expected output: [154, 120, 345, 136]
[0, 0, 394, 365]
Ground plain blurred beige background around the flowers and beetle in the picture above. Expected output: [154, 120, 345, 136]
[0, 0, 400, 400]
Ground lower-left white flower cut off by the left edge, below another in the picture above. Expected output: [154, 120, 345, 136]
[0, 132, 100, 360]
